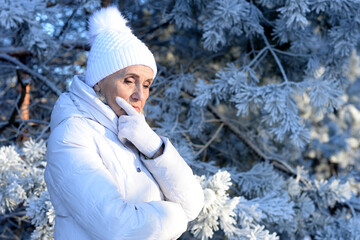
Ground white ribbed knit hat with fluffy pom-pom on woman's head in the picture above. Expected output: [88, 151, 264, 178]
[85, 7, 157, 87]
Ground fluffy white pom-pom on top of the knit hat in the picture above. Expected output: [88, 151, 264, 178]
[88, 7, 131, 44]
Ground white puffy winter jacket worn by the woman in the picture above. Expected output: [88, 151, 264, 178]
[45, 76, 203, 240]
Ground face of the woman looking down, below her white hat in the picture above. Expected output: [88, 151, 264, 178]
[94, 65, 154, 117]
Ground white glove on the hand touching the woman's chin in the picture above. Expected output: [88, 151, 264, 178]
[116, 97, 163, 158]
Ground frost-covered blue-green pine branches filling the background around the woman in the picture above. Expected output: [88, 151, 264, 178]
[0, 0, 360, 239]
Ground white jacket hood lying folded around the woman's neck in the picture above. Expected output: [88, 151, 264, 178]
[50, 75, 118, 134]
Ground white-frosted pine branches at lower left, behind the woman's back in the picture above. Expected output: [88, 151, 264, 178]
[0, 138, 55, 239]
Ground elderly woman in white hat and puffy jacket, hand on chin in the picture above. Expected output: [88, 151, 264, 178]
[45, 7, 203, 240]
